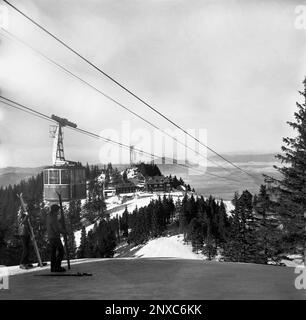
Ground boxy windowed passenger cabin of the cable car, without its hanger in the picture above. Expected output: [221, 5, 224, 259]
[44, 166, 86, 202]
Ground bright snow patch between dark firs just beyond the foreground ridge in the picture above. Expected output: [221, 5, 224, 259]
[133, 235, 206, 260]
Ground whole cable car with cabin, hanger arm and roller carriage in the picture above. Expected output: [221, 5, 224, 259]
[43, 115, 86, 203]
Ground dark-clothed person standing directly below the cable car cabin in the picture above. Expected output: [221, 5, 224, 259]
[47, 204, 66, 272]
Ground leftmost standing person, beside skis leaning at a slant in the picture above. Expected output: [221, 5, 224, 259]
[18, 211, 33, 269]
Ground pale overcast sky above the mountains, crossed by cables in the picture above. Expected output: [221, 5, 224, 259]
[0, 0, 306, 167]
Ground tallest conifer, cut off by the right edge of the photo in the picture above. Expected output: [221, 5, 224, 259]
[272, 78, 306, 264]
